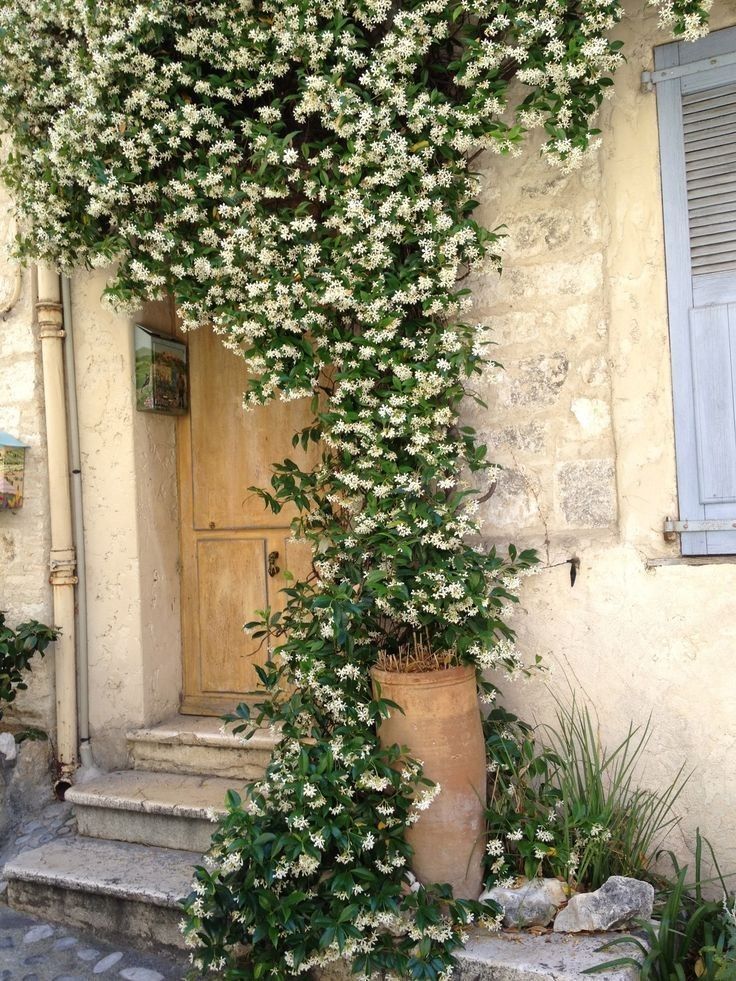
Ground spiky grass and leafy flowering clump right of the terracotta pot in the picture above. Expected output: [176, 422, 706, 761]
[486, 700, 688, 889]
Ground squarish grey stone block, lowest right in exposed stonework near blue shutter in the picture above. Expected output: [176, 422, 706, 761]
[557, 460, 617, 528]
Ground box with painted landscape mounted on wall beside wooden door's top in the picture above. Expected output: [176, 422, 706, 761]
[135, 324, 189, 416]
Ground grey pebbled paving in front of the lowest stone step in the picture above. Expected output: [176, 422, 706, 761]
[0, 904, 189, 981]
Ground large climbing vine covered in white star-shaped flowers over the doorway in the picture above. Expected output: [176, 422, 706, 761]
[0, 0, 707, 978]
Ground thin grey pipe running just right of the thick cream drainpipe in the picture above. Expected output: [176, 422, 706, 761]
[61, 276, 100, 783]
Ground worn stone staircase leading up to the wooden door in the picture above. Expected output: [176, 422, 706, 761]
[5, 715, 277, 948]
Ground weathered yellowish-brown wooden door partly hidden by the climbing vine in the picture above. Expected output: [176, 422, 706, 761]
[177, 328, 309, 715]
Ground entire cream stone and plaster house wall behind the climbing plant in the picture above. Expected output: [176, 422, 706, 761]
[0, 0, 736, 867]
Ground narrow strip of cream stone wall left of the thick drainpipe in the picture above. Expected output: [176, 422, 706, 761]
[0, 188, 55, 733]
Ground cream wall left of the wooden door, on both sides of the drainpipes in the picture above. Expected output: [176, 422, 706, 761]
[0, 192, 181, 768]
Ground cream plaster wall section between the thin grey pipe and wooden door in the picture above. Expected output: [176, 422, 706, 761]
[72, 273, 181, 769]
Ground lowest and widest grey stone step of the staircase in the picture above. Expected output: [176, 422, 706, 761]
[4, 837, 197, 949]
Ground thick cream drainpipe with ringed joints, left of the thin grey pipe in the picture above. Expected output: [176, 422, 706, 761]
[36, 266, 78, 797]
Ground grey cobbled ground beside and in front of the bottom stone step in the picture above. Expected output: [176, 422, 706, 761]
[0, 801, 194, 981]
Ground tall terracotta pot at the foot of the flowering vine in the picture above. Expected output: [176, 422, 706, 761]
[371, 667, 486, 899]
